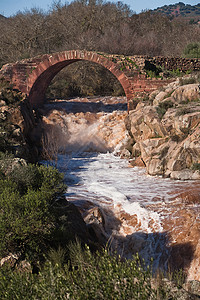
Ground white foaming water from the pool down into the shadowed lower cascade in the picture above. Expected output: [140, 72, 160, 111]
[55, 153, 168, 269]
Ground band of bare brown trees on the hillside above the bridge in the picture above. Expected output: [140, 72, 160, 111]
[0, 0, 200, 65]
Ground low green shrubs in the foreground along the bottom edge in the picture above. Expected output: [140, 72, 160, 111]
[0, 244, 158, 300]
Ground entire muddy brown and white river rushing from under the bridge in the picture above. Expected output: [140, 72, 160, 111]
[41, 98, 200, 278]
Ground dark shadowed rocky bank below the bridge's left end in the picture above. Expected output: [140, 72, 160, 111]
[0, 78, 38, 162]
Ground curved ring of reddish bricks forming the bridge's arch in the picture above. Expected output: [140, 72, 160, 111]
[26, 50, 133, 107]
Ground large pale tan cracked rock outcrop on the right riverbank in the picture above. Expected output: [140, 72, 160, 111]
[126, 79, 200, 180]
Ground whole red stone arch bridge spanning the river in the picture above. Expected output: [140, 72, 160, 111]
[0, 50, 197, 110]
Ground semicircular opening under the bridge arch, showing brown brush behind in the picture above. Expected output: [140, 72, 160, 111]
[46, 60, 125, 100]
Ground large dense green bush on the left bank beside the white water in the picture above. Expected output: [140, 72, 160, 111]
[0, 165, 66, 260]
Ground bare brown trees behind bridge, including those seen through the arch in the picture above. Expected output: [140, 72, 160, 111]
[0, 0, 200, 98]
